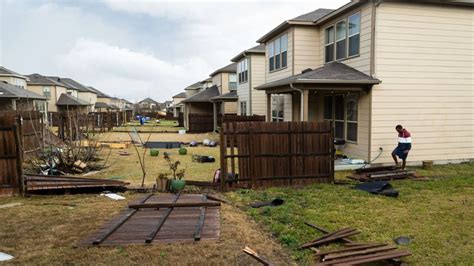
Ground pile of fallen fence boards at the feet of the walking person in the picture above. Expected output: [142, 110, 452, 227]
[347, 166, 424, 182]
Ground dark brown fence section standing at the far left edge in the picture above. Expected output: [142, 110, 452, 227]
[0, 125, 23, 196]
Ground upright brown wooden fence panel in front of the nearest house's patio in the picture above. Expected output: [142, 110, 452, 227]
[220, 121, 334, 191]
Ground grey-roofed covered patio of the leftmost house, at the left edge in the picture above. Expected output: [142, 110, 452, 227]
[0, 80, 46, 111]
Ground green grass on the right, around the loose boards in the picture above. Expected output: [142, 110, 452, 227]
[229, 163, 474, 265]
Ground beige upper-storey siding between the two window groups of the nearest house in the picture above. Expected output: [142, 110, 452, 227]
[294, 27, 324, 74]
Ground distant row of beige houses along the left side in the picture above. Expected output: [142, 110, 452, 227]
[0, 66, 133, 117]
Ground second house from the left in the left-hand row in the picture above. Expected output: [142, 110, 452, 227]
[27, 74, 68, 112]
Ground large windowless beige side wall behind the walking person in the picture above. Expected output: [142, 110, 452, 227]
[371, 2, 474, 162]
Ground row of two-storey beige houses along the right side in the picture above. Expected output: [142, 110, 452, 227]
[171, 0, 474, 162]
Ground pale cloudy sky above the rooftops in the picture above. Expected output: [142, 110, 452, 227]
[0, 0, 349, 101]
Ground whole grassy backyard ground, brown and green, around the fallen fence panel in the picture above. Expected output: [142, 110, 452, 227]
[0, 123, 474, 265]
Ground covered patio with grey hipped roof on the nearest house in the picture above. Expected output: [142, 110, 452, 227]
[256, 62, 380, 161]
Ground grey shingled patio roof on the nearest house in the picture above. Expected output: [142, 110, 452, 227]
[255, 62, 381, 90]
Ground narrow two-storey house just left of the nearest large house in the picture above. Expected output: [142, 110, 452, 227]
[231, 44, 267, 115]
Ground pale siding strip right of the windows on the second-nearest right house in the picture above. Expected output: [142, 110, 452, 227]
[248, 54, 267, 115]
